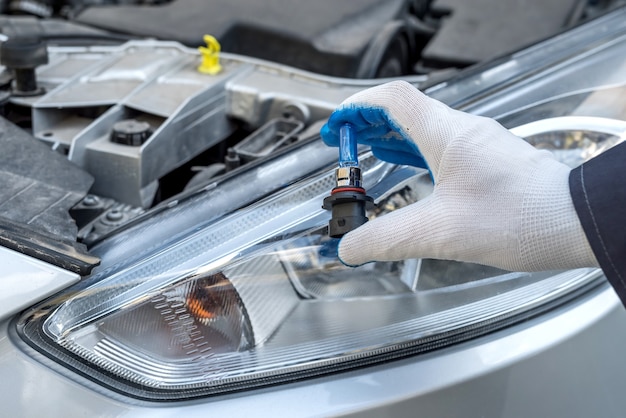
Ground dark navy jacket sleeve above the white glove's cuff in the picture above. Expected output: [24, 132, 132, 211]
[569, 143, 626, 306]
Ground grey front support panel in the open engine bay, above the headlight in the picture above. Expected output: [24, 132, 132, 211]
[3, 41, 394, 251]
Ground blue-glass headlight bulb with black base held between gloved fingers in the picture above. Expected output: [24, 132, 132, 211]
[322, 124, 374, 238]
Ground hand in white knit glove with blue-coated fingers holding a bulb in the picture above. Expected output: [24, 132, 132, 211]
[321, 81, 598, 271]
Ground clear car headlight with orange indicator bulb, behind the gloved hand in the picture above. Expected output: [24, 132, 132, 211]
[18, 9, 626, 401]
